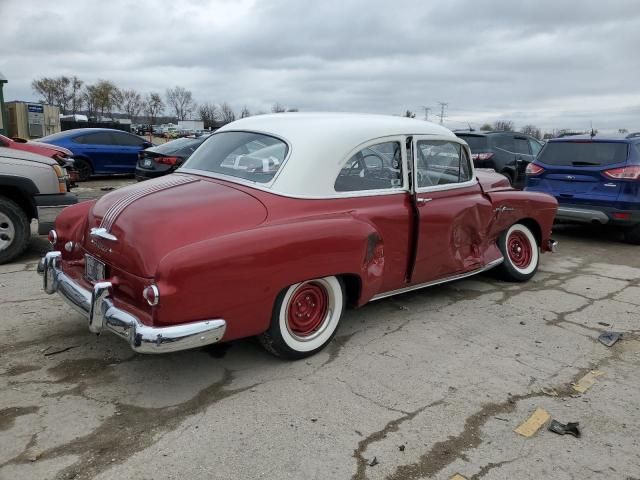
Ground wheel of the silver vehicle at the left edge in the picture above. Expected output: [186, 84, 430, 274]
[0, 197, 31, 264]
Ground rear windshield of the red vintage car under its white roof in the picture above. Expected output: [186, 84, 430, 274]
[183, 132, 288, 183]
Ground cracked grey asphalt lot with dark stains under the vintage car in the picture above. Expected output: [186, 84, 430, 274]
[0, 179, 640, 480]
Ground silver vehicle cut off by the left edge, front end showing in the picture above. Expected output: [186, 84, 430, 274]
[0, 147, 78, 264]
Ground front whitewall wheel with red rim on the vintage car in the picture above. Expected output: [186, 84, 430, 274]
[497, 223, 540, 282]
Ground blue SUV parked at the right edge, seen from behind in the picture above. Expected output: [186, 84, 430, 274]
[525, 133, 640, 244]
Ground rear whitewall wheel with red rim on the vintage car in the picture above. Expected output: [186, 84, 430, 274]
[259, 277, 346, 359]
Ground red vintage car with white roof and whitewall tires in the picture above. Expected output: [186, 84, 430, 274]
[39, 113, 557, 358]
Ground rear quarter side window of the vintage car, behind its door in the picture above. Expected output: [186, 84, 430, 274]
[334, 142, 402, 192]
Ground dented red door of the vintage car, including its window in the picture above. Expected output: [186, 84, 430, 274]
[410, 136, 493, 284]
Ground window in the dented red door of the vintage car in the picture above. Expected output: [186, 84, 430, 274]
[416, 140, 471, 188]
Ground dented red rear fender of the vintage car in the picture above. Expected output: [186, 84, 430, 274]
[154, 214, 384, 340]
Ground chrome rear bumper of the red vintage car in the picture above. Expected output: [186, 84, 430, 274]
[38, 252, 227, 353]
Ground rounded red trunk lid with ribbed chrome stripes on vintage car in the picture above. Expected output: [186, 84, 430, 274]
[83, 174, 267, 278]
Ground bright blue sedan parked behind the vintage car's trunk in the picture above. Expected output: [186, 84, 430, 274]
[39, 128, 152, 180]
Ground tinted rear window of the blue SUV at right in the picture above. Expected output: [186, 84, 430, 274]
[538, 141, 628, 167]
